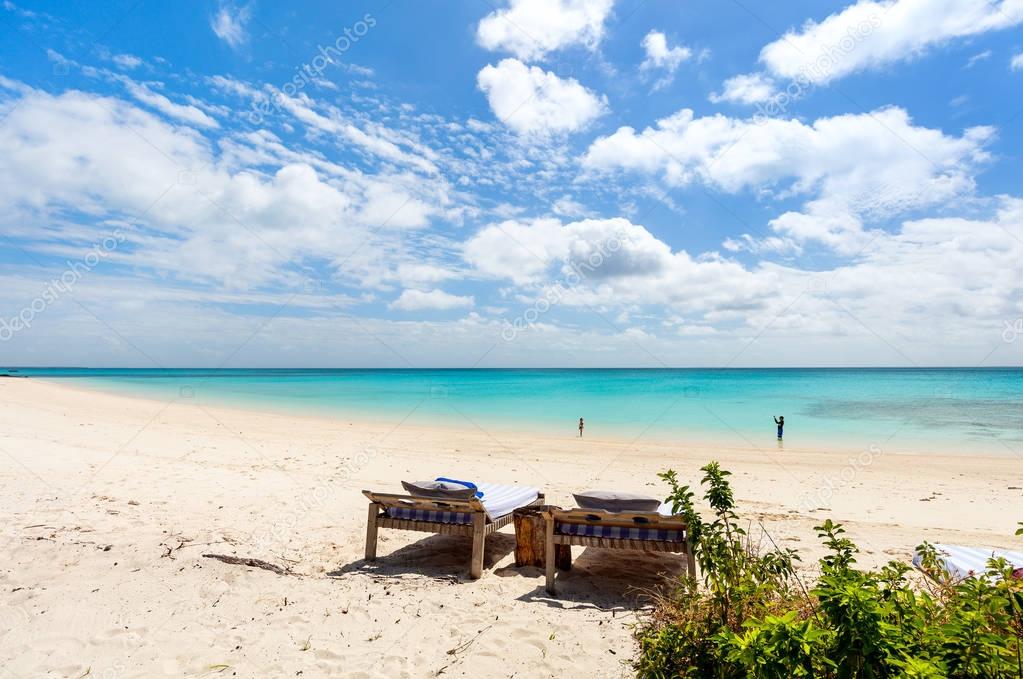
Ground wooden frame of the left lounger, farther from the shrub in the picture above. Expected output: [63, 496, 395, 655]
[362, 491, 544, 579]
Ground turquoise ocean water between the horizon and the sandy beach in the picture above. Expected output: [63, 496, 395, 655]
[7, 368, 1023, 457]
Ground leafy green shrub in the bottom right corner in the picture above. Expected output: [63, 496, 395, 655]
[634, 462, 1023, 679]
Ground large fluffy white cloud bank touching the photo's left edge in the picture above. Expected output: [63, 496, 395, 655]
[0, 80, 444, 289]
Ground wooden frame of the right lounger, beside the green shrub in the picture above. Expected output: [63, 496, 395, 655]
[542, 509, 697, 594]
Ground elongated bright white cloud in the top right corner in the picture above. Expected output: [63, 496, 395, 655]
[760, 0, 1023, 85]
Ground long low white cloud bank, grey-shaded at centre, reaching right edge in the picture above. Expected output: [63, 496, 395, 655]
[466, 205, 1023, 365]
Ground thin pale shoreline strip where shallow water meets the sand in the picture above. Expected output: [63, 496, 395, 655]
[24, 375, 1019, 460]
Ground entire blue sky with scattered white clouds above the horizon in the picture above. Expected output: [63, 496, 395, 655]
[0, 0, 1023, 368]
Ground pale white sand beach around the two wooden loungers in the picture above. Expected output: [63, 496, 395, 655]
[0, 379, 1023, 679]
